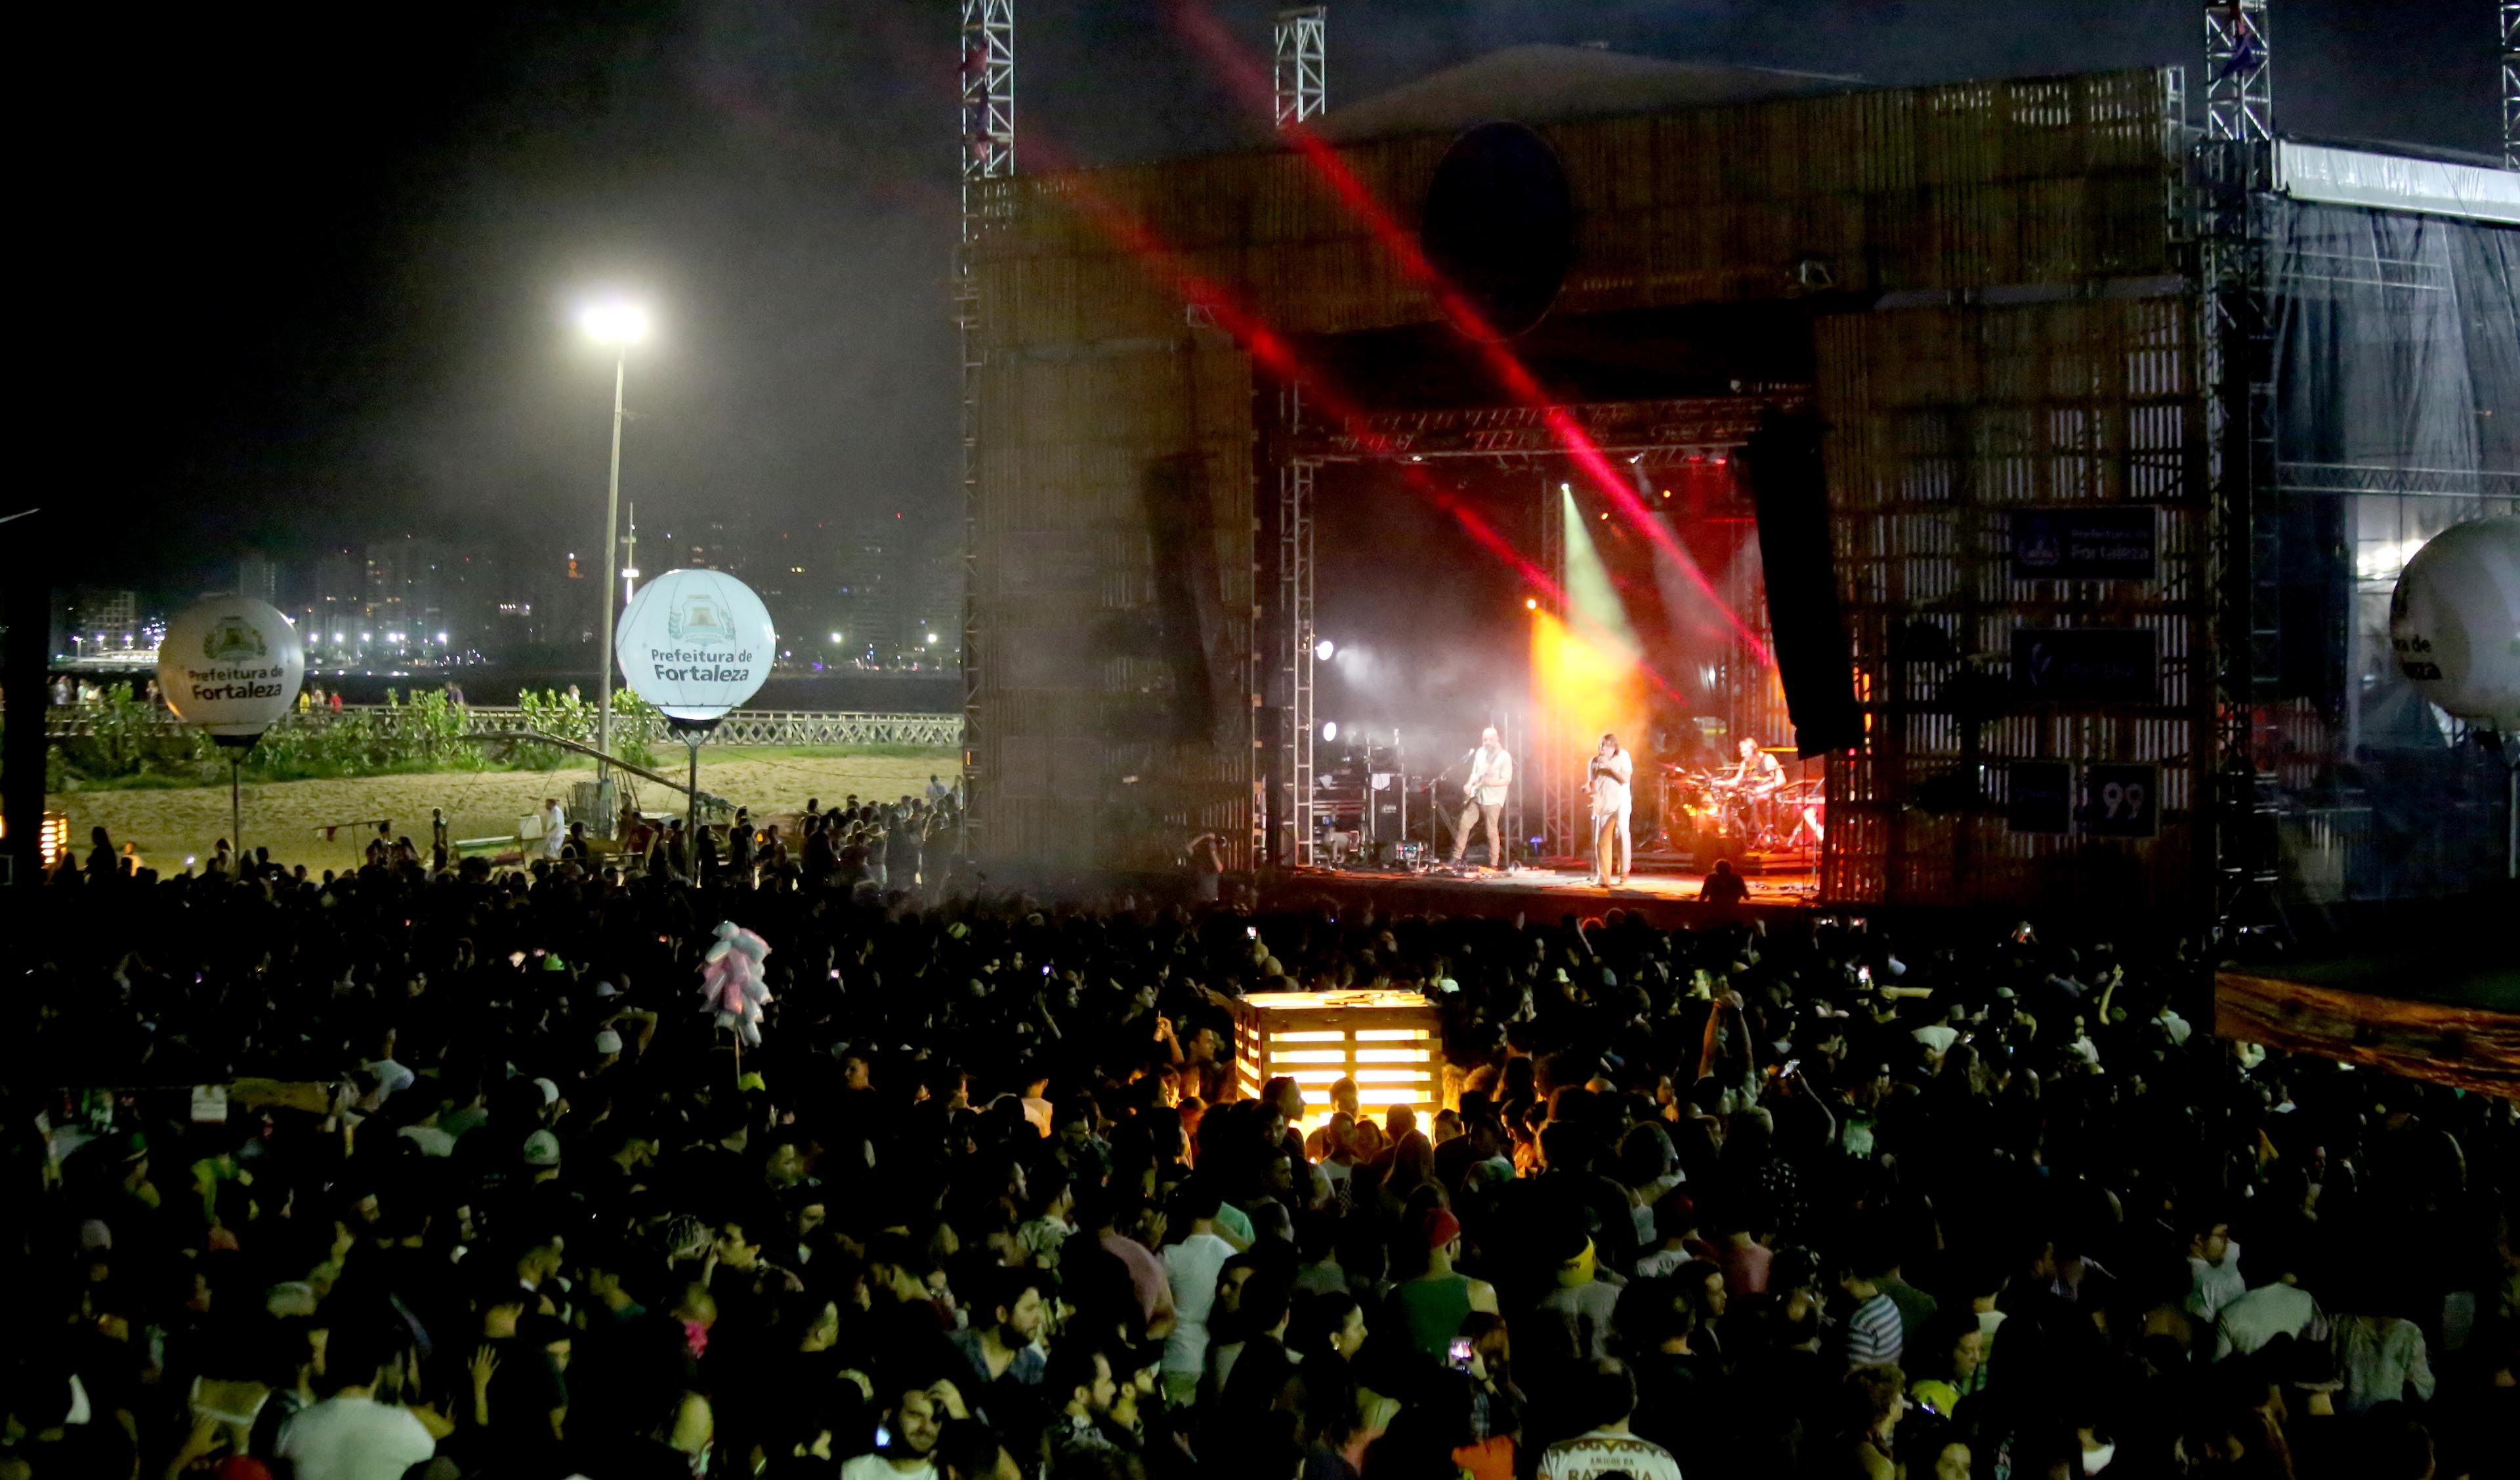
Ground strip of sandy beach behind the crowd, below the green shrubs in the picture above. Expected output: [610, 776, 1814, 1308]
[45, 755, 953, 871]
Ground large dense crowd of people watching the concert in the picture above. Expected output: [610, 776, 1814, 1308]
[0, 846, 2520, 1480]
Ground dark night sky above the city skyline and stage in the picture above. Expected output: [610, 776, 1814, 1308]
[59, 0, 2500, 594]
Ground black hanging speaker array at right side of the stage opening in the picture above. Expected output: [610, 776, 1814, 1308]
[1741, 415, 1865, 755]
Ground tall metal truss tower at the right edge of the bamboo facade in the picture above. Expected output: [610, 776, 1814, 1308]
[2195, 0, 2283, 914]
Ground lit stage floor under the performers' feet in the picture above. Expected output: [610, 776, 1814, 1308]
[1263, 869, 1817, 929]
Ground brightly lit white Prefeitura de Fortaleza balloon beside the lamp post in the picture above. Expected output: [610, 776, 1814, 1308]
[612, 569, 779, 720]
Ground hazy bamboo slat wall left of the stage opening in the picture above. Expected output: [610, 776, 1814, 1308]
[973, 332, 1255, 869]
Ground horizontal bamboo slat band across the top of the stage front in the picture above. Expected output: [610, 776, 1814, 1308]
[980, 70, 2180, 345]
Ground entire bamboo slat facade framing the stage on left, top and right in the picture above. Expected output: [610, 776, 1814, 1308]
[973, 70, 2202, 899]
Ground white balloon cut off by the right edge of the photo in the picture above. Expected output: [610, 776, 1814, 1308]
[2389, 514, 2520, 730]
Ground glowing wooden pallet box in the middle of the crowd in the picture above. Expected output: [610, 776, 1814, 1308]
[1227, 992, 1444, 1135]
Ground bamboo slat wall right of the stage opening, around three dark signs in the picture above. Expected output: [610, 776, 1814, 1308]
[1819, 295, 2213, 906]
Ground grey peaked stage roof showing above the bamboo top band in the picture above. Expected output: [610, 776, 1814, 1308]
[1313, 45, 1860, 144]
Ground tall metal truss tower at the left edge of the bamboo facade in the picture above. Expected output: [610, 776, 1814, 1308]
[953, 0, 1016, 851]
